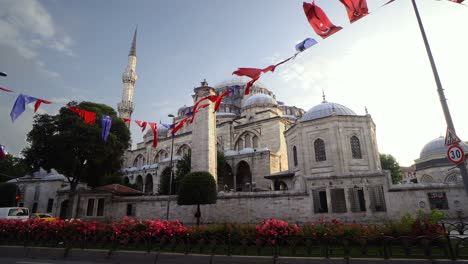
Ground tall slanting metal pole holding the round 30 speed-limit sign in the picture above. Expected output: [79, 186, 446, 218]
[412, 0, 468, 195]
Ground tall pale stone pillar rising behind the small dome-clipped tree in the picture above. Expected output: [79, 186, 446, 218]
[192, 81, 218, 183]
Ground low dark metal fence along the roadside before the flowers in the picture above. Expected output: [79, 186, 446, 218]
[0, 219, 468, 260]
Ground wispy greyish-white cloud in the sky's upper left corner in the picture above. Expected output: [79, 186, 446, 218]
[0, 0, 73, 73]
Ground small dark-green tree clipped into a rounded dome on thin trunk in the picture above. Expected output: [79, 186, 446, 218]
[177, 171, 217, 226]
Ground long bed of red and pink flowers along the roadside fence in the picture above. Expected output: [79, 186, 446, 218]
[0, 213, 444, 249]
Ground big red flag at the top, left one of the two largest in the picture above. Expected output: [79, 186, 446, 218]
[302, 1, 342, 38]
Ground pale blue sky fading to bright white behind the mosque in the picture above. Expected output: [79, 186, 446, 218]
[0, 0, 468, 166]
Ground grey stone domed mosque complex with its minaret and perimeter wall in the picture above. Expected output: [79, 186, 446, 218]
[11, 31, 468, 223]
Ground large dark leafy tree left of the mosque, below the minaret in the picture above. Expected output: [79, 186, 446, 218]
[22, 102, 130, 217]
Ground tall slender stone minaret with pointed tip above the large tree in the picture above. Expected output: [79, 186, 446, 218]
[117, 28, 138, 118]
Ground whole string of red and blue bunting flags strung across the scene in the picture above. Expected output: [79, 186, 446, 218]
[0, 0, 464, 159]
